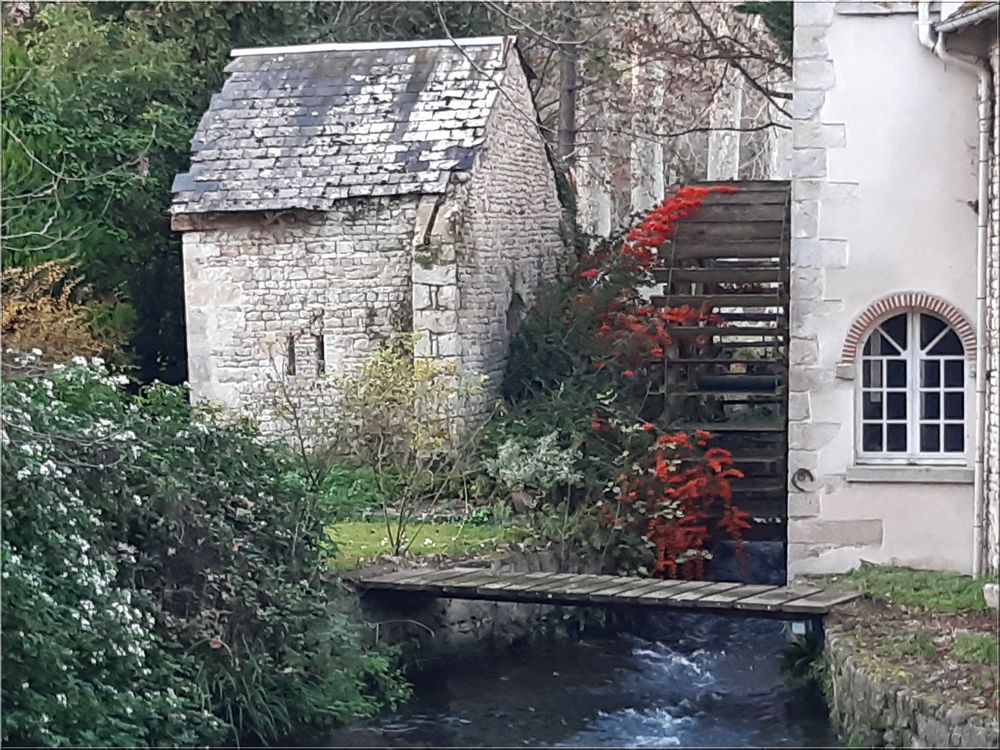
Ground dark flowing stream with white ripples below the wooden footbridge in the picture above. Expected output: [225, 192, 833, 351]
[309, 614, 838, 747]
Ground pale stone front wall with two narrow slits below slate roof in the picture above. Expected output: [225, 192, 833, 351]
[184, 198, 417, 433]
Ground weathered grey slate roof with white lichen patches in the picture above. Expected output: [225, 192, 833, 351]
[172, 37, 512, 214]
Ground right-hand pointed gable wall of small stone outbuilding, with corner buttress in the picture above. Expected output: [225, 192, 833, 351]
[413, 53, 566, 416]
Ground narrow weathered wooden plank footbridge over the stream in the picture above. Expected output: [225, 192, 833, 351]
[355, 567, 860, 620]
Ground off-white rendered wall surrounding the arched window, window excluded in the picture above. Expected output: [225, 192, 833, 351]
[788, 3, 977, 577]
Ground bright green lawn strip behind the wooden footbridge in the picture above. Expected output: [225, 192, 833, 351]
[329, 519, 525, 571]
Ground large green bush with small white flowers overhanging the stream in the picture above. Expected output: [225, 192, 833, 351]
[2, 356, 403, 746]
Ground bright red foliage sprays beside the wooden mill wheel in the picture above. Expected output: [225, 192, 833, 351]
[574, 186, 750, 578]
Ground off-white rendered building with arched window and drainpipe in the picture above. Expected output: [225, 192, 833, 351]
[788, 2, 1000, 576]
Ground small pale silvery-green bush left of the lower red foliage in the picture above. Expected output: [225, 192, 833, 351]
[483, 432, 583, 494]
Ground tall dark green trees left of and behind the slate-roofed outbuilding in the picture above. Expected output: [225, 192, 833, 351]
[2, 0, 495, 383]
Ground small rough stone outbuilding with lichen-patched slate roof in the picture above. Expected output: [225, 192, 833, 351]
[172, 37, 564, 438]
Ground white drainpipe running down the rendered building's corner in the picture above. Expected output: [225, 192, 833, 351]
[917, 14, 992, 576]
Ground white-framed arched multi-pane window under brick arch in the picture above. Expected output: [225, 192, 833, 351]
[858, 310, 967, 463]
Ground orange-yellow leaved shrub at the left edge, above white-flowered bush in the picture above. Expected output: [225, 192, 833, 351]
[2, 259, 124, 361]
